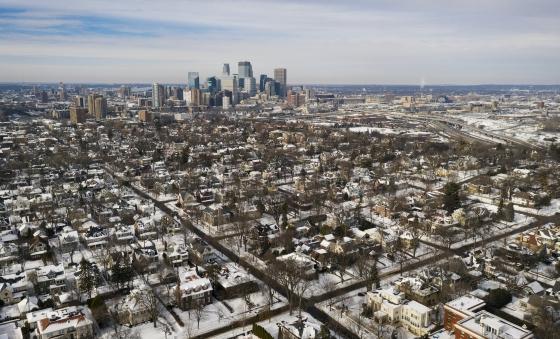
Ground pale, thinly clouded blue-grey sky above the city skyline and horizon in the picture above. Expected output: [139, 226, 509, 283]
[0, 0, 560, 85]
